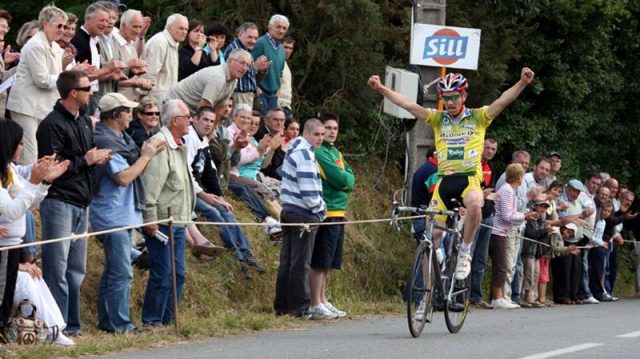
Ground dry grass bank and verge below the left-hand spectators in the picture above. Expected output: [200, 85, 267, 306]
[0, 159, 415, 359]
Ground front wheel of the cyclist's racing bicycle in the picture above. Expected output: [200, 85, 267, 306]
[407, 242, 434, 338]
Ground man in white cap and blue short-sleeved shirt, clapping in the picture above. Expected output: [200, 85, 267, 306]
[89, 93, 166, 333]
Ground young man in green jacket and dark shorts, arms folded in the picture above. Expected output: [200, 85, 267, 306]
[309, 114, 355, 319]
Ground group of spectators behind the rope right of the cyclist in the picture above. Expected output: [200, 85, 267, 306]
[412, 138, 640, 309]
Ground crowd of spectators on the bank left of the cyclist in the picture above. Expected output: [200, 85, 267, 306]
[0, 0, 354, 345]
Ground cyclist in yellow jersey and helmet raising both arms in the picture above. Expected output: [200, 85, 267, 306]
[368, 67, 534, 280]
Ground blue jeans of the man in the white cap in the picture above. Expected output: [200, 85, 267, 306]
[98, 230, 135, 333]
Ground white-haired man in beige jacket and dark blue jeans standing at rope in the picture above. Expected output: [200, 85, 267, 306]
[142, 100, 195, 326]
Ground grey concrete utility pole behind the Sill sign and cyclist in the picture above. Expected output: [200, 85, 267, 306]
[407, 0, 447, 205]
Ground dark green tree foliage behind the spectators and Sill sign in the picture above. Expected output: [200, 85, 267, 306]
[2, 0, 640, 188]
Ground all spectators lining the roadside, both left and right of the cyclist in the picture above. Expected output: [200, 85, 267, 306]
[0, 0, 640, 345]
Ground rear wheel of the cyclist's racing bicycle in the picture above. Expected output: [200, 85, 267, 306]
[442, 241, 471, 334]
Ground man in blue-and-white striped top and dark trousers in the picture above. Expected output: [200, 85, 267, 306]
[273, 118, 327, 317]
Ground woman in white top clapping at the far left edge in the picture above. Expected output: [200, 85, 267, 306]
[0, 118, 69, 346]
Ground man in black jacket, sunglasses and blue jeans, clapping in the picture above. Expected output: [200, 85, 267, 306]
[36, 70, 111, 336]
